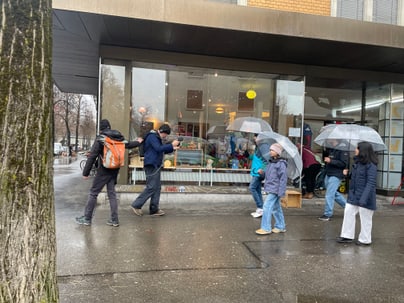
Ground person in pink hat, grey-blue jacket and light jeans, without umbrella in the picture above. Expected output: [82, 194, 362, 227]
[255, 143, 288, 235]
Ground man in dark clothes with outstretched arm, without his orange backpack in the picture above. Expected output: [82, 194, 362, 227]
[76, 119, 143, 227]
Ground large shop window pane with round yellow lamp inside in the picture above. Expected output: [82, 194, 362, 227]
[130, 66, 278, 169]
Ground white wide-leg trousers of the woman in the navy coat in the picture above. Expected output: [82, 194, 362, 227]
[341, 203, 374, 244]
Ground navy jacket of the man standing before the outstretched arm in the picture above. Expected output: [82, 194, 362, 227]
[143, 130, 174, 168]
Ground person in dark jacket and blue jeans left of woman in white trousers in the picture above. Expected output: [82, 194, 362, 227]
[318, 139, 349, 221]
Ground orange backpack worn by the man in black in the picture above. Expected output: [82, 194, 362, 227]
[100, 135, 126, 169]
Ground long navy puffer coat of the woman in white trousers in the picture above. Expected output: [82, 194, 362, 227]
[347, 160, 377, 210]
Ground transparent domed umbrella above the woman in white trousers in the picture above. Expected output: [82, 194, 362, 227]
[314, 124, 386, 151]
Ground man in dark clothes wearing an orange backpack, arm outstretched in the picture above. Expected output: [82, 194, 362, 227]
[76, 119, 143, 227]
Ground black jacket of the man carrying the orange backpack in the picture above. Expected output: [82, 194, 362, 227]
[83, 129, 140, 177]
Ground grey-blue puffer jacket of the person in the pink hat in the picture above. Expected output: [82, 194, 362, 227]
[264, 158, 288, 197]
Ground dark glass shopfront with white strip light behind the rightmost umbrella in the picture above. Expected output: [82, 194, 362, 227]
[304, 79, 404, 190]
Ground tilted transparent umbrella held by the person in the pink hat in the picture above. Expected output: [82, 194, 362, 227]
[256, 132, 303, 180]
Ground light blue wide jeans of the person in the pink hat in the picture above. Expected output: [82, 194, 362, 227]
[261, 193, 286, 231]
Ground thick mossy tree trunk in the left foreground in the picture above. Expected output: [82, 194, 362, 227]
[0, 0, 58, 303]
